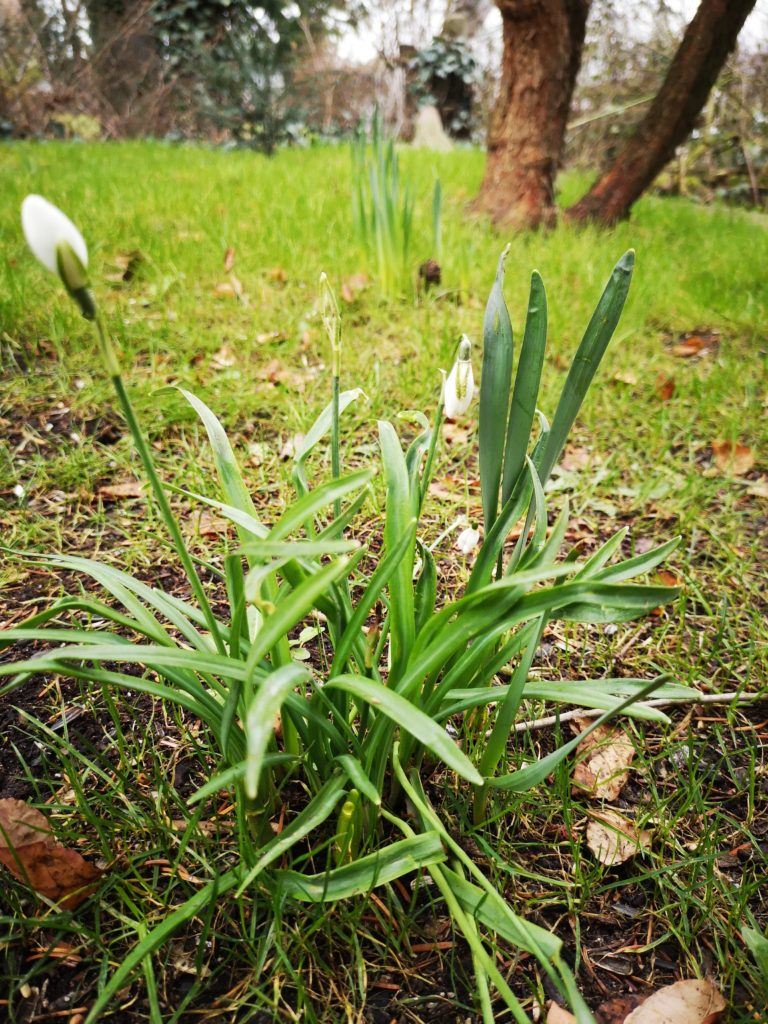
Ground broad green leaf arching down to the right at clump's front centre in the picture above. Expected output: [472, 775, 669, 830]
[326, 675, 482, 785]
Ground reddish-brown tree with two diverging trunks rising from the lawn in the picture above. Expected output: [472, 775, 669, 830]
[476, 0, 756, 227]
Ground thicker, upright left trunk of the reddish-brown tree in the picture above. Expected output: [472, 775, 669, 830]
[475, 0, 590, 228]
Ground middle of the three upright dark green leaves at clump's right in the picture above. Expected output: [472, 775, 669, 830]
[502, 270, 547, 505]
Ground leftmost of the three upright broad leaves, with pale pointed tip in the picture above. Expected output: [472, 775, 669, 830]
[478, 246, 513, 534]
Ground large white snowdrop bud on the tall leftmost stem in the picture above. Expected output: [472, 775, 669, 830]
[22, 196, 96, 319]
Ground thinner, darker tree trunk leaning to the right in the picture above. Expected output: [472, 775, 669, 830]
[567, 0, 756, 224]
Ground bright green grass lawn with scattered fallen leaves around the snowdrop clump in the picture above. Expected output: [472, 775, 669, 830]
[0, 142, 768, 1024]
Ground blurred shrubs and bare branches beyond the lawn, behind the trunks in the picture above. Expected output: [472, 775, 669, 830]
[0, 0, 768, 206]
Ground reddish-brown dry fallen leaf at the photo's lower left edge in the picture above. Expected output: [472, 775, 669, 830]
[0, 799, 101, 910]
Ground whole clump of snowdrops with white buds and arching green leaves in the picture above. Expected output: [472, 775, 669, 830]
[0, 197, 685, 1022]
